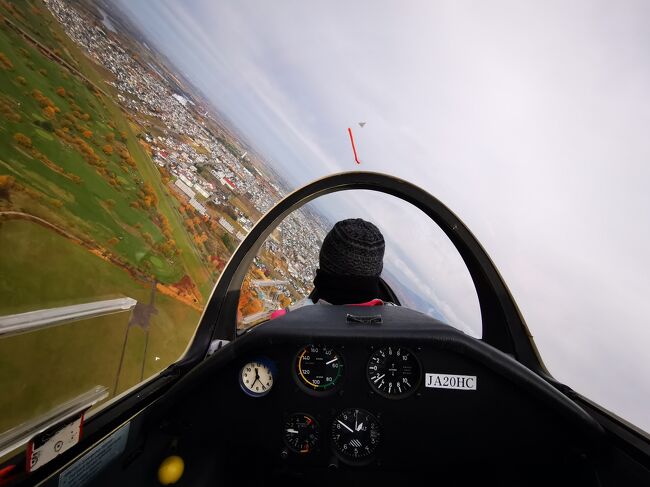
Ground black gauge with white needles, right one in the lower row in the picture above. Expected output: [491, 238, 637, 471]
[332, 409, 381, 463]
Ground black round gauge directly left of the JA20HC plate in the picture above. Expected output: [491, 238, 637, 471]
[366, 346, 422, 399]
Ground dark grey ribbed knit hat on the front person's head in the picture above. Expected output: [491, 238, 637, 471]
[319, 218, 386, 276]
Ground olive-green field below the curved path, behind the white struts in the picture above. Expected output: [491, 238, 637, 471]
[0, 221, 200, 431]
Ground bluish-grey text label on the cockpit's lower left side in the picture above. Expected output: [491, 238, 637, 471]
[59, 423, 131, 487]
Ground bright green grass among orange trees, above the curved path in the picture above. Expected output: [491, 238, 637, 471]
[0, 16, 185, 283]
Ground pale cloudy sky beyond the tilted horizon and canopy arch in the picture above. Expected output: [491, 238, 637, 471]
[113, 0, 650, 431]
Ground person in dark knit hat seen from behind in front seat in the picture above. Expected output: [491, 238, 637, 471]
[271, 218, 387, 319]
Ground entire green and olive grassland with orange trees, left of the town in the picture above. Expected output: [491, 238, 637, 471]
[0, 0, 215, 433]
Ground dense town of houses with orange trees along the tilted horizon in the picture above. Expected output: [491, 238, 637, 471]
[45, 0, 326, 322]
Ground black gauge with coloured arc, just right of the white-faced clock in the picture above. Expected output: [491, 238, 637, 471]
[296, 345, 343, 392]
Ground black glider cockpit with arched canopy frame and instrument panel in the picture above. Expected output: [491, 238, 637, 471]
[5, 172, 650, 486]
